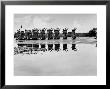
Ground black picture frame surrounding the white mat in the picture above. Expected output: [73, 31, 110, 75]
[1, 1, 110, 89]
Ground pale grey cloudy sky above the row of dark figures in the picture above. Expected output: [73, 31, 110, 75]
[14, 14, 97, 33]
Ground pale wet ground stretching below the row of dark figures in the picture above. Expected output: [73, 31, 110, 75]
[14, 37, 97, 76]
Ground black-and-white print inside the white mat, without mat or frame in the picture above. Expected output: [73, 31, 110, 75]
[13, 13, 99, 76]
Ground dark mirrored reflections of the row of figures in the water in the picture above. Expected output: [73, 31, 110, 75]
[14, 44, 77, 54]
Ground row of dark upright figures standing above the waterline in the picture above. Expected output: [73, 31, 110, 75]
[14, 28, 76, 40]
